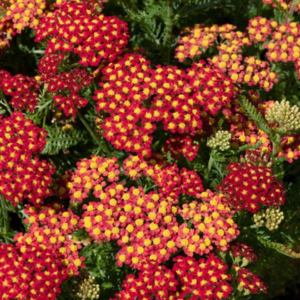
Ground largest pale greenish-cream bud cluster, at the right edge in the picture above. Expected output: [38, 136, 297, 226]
[266, 100, 300, 132]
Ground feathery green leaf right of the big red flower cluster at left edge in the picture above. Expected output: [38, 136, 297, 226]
[42, 126, 87, 155]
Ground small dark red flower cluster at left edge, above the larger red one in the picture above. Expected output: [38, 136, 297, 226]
[0, 70, 39, 113]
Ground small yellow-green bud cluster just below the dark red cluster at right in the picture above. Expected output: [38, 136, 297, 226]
[253, 207, 284, 231]
